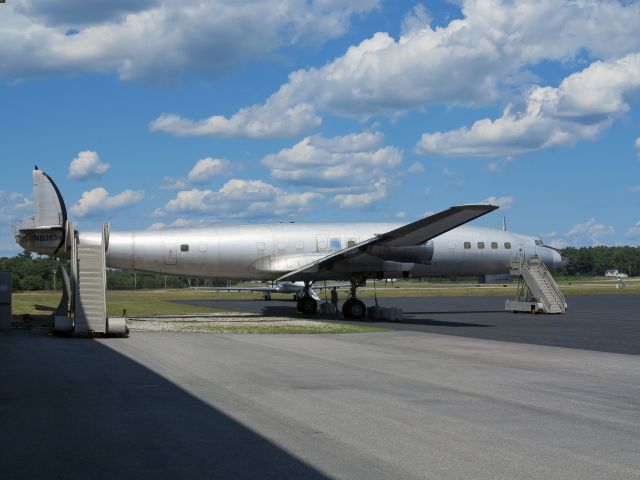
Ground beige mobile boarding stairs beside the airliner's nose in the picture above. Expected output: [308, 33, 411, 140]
[505, 255, 567, 313]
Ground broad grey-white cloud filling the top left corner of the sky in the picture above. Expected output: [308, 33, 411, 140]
[0, 0, 378, 83]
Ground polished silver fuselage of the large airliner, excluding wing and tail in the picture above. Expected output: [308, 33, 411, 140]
[80, 223, 563, 280]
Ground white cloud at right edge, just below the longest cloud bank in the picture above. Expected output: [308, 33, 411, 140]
[416, 53, 640, 156]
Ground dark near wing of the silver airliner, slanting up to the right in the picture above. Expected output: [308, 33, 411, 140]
[276, 204, 498, 282]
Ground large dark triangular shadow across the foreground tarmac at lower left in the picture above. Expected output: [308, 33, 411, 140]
[0, 331, 327, 479]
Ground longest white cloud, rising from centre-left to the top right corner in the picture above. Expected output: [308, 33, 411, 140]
[151, 0, 640, 138]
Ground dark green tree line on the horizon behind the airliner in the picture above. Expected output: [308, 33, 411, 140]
[0, 246, 640, 291]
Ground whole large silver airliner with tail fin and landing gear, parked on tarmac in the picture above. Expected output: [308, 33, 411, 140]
[16, 167, 565, 318]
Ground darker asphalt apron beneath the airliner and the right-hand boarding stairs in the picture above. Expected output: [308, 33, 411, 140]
[175, 293, 640, 355]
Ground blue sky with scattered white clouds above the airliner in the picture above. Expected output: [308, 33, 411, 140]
[0, 0, 640, 255]
